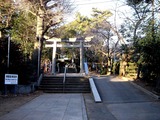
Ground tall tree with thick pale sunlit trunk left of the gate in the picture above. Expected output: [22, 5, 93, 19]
[16, 0, 70, 75]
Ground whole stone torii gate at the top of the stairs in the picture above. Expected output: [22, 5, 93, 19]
[45, 36, 93, 74]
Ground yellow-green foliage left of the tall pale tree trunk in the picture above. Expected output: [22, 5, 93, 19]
[11, 12, 36, 58]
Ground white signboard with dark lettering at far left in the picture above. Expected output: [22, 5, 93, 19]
[5, 74, 18, 85]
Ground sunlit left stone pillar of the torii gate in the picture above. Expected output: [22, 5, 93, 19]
[52, 41, 57, 74]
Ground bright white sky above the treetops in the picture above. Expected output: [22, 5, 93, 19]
[65, 0, 131, 25]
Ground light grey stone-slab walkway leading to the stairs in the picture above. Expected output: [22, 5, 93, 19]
[0, 94, 87, 120]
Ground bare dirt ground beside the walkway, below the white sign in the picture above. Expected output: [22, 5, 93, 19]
[0, 91, 43, 116]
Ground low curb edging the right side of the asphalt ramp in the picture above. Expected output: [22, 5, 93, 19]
[128, 80, 160, 100]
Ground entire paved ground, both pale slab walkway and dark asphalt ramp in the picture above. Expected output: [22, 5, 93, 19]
[0, 77, 160, 120]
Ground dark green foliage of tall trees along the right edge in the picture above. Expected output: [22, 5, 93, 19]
[122, 0, 160, 81]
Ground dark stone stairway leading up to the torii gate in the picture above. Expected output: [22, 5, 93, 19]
[39, 76, 91, 93]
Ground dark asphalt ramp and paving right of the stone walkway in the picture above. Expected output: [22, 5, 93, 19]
[85, 77, 160, 120]
